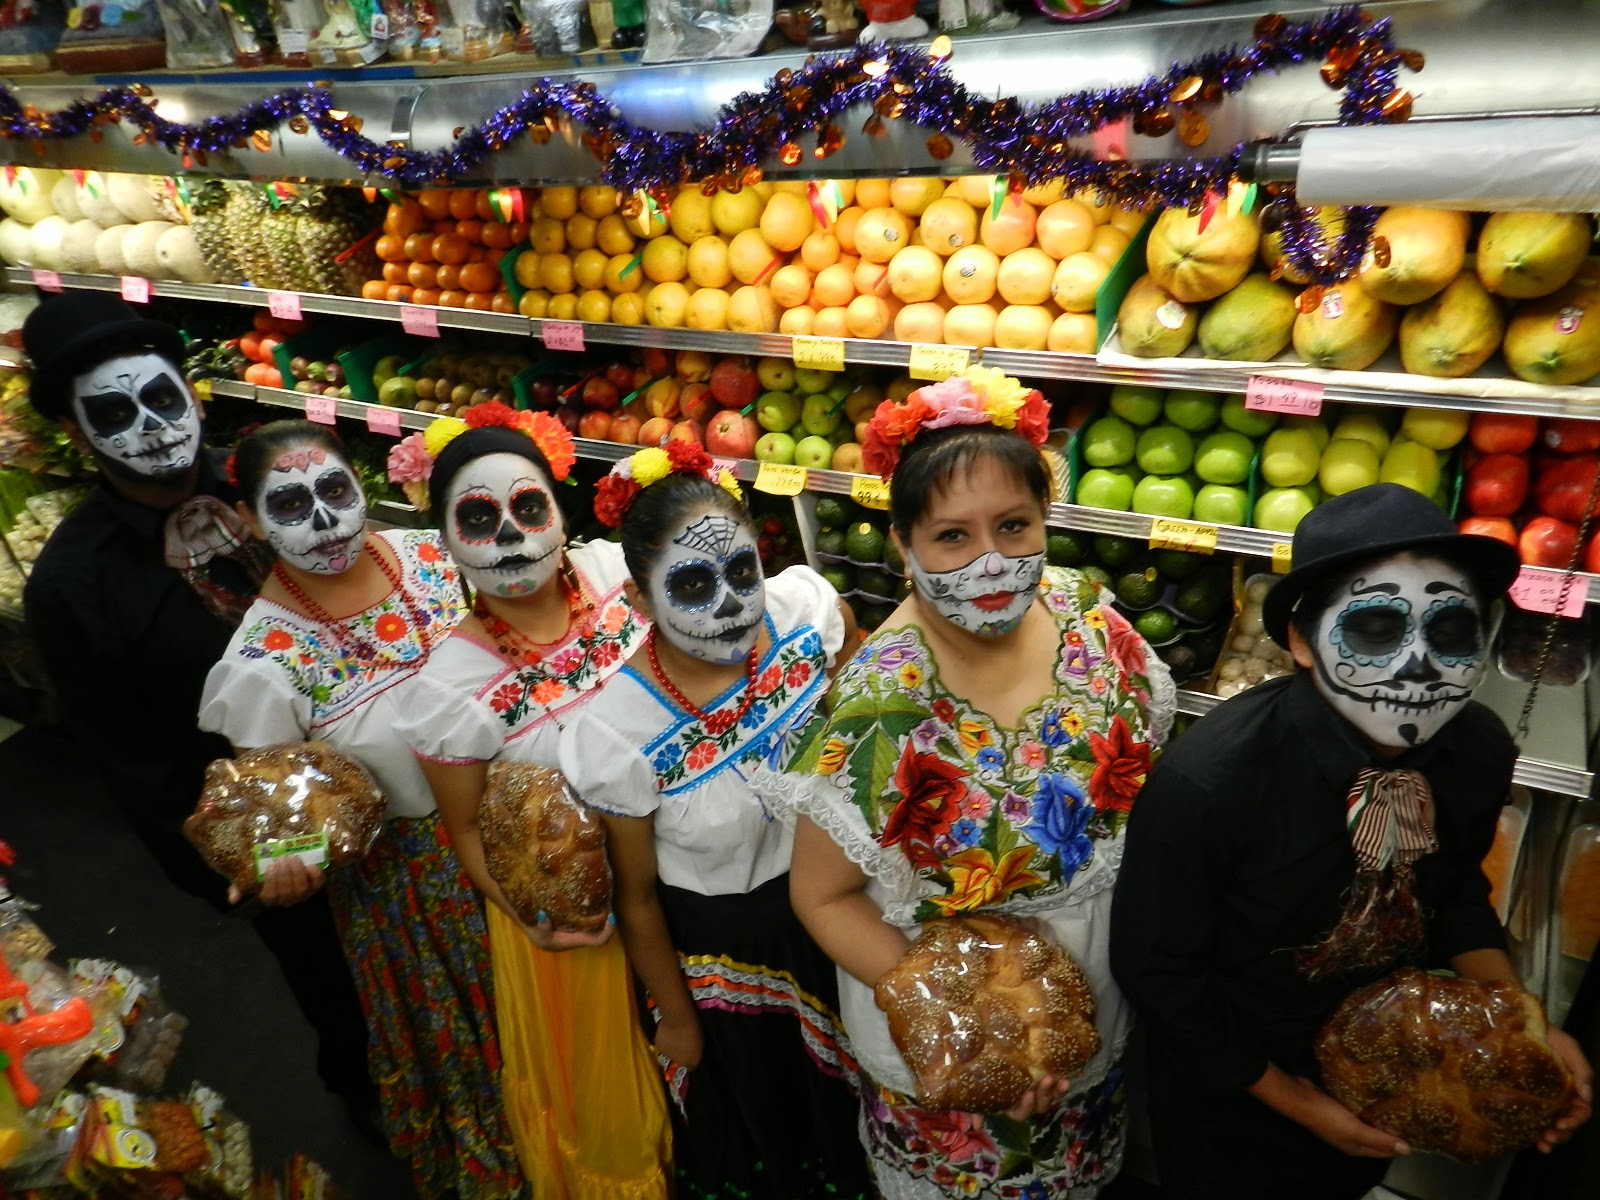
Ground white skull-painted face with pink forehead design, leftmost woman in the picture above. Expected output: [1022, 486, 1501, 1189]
[256, 446, 366, 574]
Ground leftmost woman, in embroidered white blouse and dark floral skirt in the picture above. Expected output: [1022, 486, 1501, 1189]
[200, 421, 525, 1200]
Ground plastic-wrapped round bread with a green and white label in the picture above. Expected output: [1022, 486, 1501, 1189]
[184, 742, 384, 896]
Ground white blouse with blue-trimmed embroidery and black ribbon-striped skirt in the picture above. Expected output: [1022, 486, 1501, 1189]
[562, 566, 866, 1200]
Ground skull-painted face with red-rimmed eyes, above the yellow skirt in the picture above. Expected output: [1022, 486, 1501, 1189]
[445, 451, 566, 598]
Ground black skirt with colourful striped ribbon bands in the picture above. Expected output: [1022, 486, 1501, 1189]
[659, 875, 872, 1200]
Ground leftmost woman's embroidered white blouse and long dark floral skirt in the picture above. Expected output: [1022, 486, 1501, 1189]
[191, 531, 525, 1200]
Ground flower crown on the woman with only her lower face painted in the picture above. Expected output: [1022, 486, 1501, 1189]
[861, 366, 1050, 478]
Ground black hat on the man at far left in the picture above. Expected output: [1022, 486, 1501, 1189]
[22, 291, 184, 418]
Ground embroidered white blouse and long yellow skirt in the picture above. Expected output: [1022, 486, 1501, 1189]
[402, 542, 672, 1200]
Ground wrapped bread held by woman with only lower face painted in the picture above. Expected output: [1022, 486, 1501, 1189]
[875, 915, 1099, 1112]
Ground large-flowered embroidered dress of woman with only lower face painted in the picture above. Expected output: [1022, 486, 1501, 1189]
[773, 568, 1176, 1200]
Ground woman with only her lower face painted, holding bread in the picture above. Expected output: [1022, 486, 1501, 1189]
[781, 368, 1176, 1200]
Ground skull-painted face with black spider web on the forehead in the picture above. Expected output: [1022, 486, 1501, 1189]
[648, 512, 766, 666]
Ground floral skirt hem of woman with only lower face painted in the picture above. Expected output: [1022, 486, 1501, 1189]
[861, 1066, 1128, 1200]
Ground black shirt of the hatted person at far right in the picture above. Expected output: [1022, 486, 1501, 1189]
[1110, 672, 1517, 1094]
